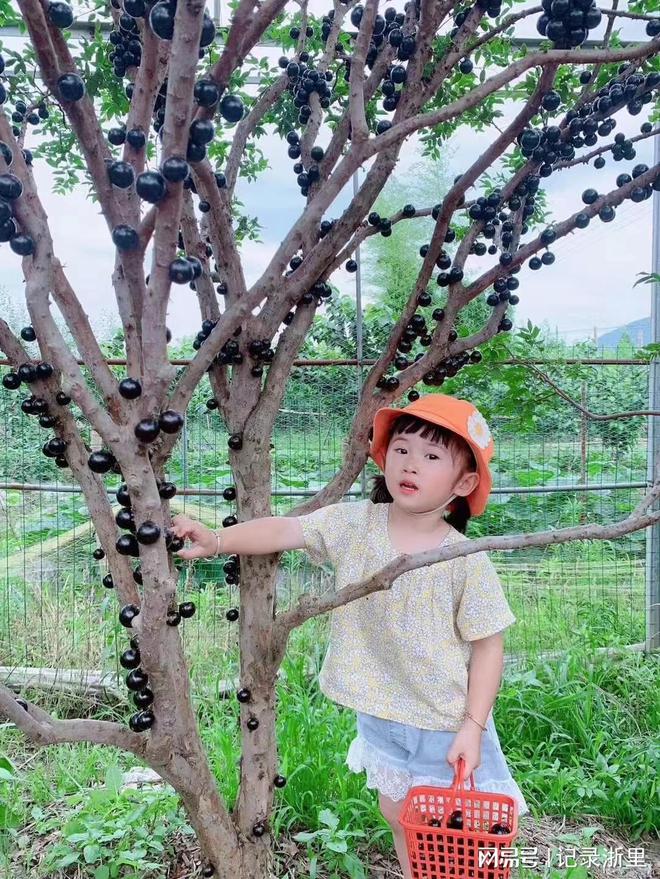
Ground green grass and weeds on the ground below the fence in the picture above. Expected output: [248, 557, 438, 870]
[0, 620, 660, 879]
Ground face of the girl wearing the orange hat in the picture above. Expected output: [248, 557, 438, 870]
[385, 433, 479, 511]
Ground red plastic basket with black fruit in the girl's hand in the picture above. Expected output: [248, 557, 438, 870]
[399, 757, 518, 879]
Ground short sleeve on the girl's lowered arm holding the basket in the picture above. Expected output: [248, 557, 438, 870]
[456, 552, 516, 641]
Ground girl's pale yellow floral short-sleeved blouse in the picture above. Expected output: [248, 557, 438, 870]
[299, 500, 516, 731]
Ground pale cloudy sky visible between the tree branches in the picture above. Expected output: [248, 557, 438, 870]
[0, 0, 660, 342]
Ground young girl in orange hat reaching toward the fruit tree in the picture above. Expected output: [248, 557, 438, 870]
[174, 394, 529, 879]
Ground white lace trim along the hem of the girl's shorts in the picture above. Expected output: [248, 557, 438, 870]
[346, 736, 529, 817]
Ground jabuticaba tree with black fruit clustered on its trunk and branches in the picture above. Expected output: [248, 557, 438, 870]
[0, 0, 660, 879]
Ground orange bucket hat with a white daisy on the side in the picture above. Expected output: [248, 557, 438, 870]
[369, 394, 495, 516]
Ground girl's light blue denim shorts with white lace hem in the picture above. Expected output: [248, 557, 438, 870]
[346, 711, 529, 816]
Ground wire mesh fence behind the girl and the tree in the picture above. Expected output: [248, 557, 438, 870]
[0, 348, 660, 692]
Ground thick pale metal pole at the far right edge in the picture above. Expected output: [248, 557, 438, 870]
[645, 131, 660, 653]
